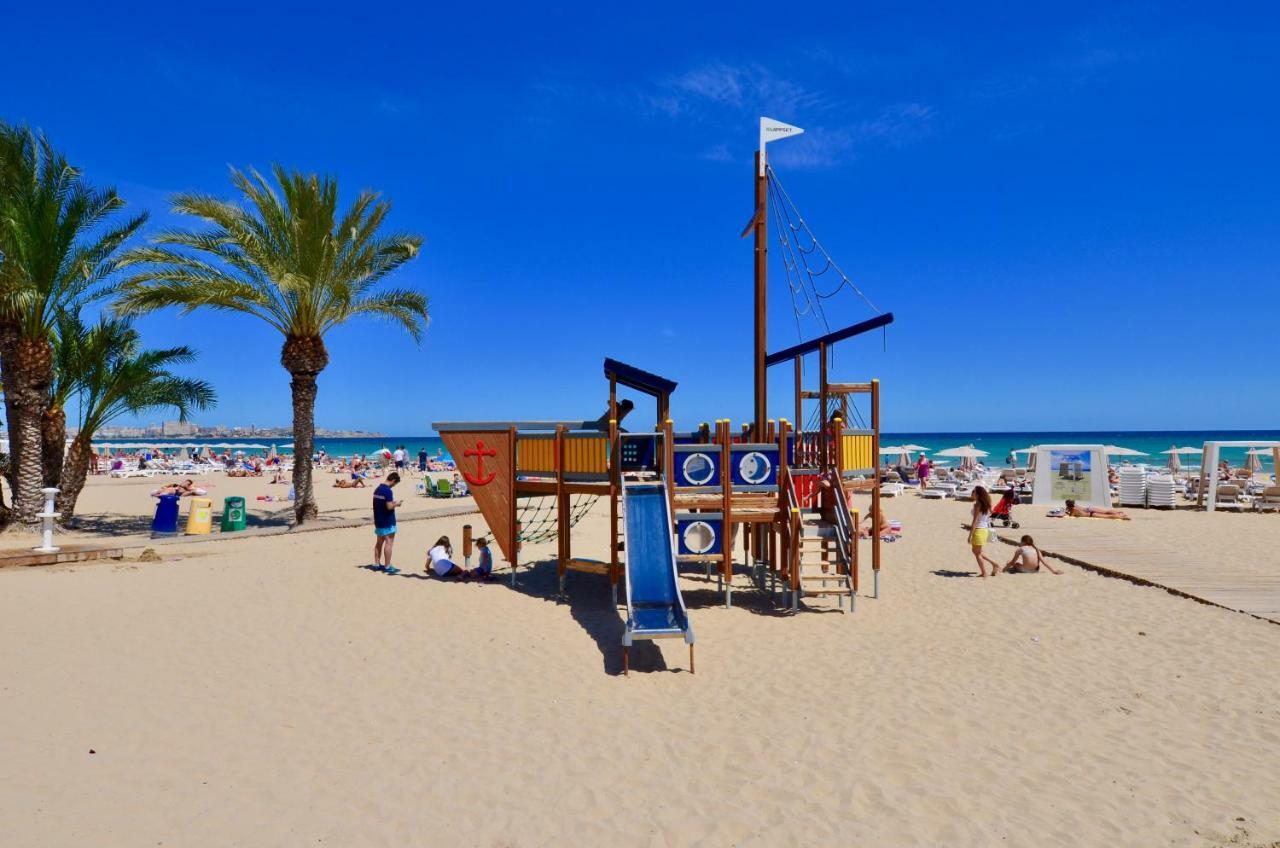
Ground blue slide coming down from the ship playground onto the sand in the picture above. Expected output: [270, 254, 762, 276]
[622, 482, 694, 674]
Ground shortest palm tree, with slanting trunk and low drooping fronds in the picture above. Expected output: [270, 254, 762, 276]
[56, 318, 216, 521]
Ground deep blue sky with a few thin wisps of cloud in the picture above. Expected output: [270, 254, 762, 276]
[0, 3, 1280, 433]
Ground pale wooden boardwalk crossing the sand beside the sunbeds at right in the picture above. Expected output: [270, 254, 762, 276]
[996, 519, 1280, 624]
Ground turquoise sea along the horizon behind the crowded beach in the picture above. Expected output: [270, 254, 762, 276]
[94, 430, 1280, 470]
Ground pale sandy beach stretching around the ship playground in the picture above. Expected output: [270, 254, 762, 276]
[0, 477, 1280, 847]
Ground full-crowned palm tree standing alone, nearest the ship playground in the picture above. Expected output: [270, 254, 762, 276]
[116, 165, 429, 524]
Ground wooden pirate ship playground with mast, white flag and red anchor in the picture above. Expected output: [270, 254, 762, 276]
[433, 119, 893, 670]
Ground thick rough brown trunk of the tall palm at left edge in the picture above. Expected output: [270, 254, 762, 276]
[5, 339, 54, 526]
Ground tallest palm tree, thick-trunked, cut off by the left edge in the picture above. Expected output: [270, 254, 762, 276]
[0, 127, 146, 525]
